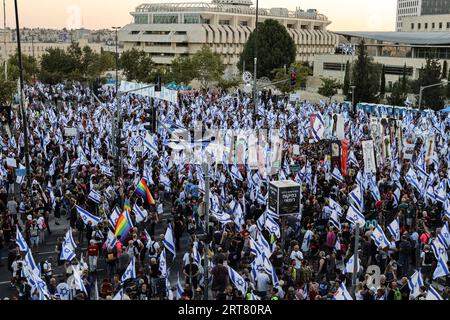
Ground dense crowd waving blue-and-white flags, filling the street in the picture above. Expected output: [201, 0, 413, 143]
[0, 83, 450, 300]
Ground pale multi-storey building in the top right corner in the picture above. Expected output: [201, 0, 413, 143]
[395, 0, 450, 31]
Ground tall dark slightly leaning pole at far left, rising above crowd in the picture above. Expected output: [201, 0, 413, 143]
[14, 0, 32, 199]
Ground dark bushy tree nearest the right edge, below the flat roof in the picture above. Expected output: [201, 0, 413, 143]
[419, 59, 444, 110]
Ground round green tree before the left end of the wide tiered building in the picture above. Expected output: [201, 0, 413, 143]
[119, 48, 154, 83]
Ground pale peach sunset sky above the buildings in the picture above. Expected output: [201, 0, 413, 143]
[5, 0, 397, 31]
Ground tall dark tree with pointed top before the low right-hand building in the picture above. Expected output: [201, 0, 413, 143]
[352, 40, 381, 103]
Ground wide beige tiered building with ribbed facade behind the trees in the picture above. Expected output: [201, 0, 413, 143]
[119, 0, 338, 73]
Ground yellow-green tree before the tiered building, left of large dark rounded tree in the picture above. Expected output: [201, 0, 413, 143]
[192, 45, 225, 89]
